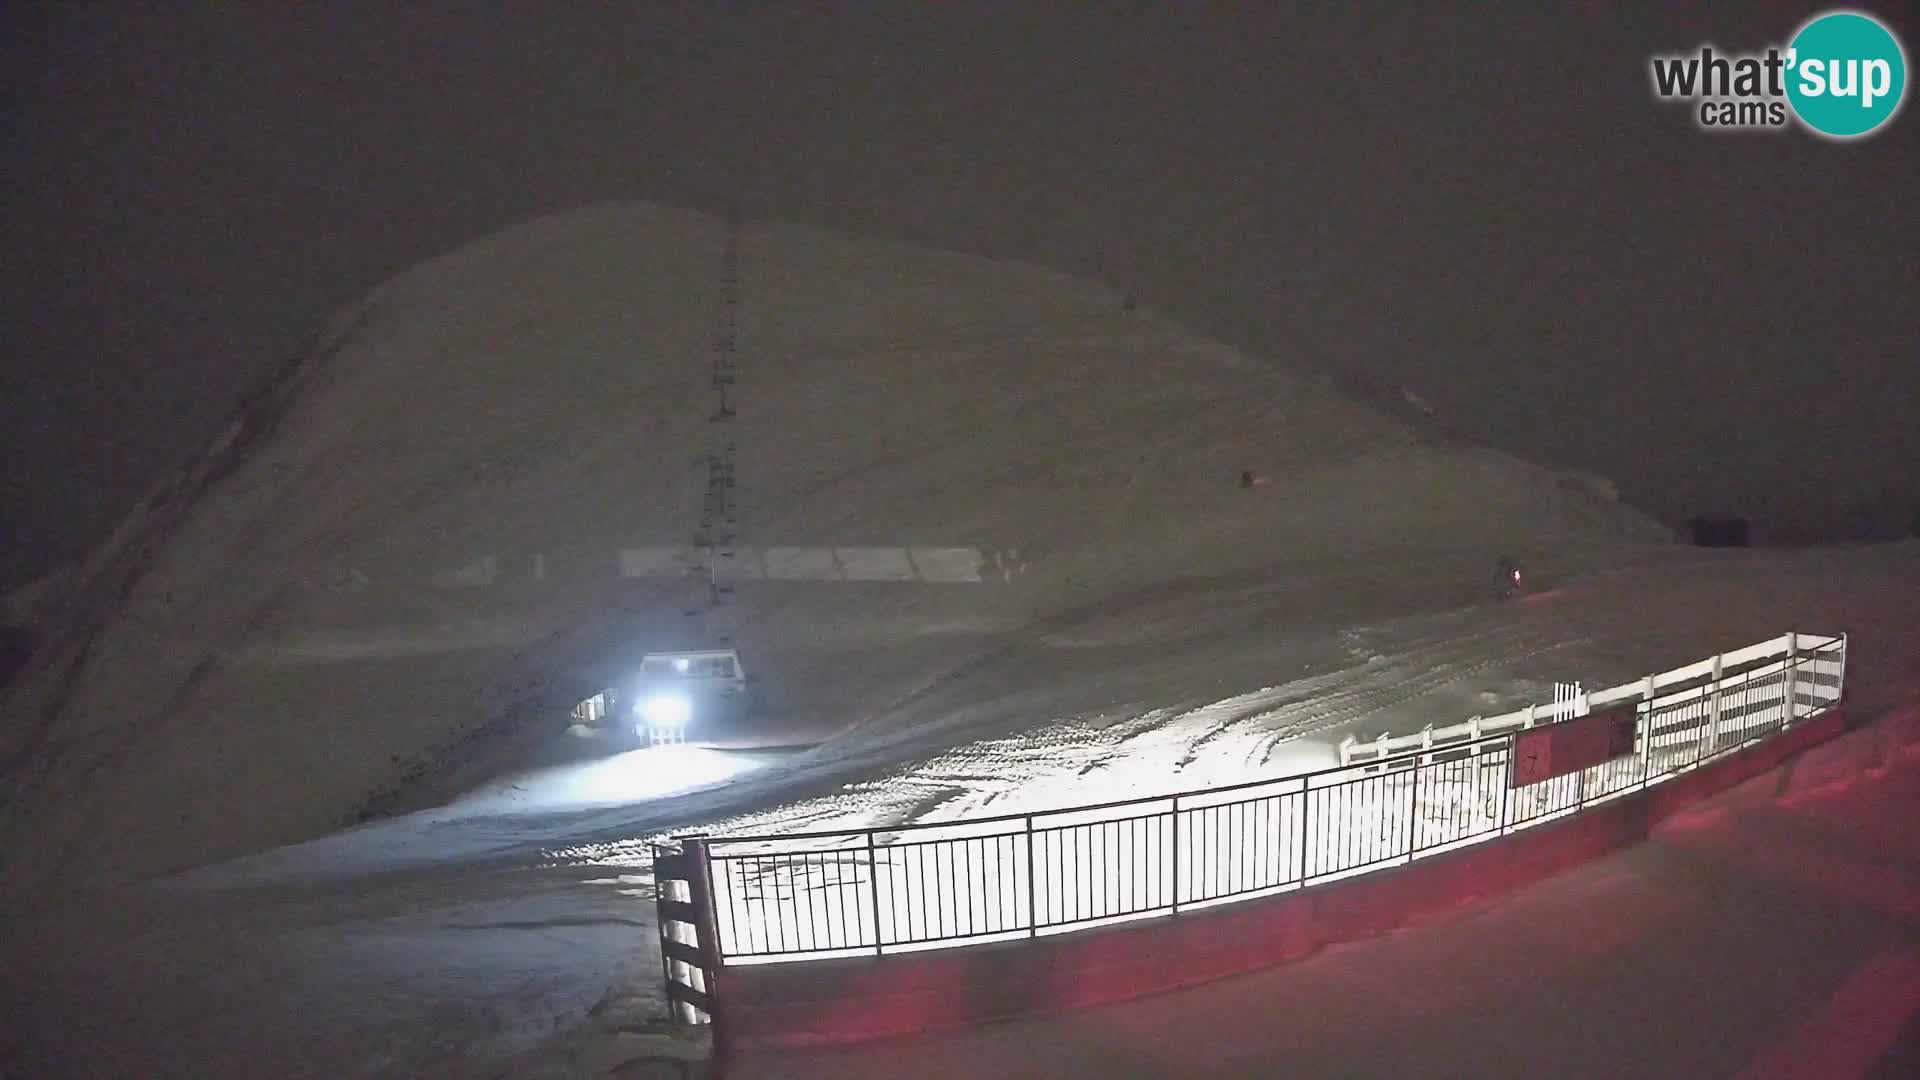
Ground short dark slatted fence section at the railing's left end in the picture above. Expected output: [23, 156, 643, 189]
[651, 836, 726, 1055]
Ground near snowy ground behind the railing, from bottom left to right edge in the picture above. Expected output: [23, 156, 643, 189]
[11, 544, 1920, 1078]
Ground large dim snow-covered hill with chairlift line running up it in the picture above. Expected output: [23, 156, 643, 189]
[0, 206, 1666, 888]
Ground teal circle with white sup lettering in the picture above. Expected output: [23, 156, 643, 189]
[1788, 12, 1907, 138]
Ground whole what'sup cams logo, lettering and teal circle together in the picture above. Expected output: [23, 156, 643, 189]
[1651, 12, 1907, 138]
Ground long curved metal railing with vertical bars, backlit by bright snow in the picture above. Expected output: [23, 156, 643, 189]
[675, 634, 1845, 963]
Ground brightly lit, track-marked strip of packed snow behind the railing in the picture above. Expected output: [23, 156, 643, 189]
[172, 553, 1628, 882]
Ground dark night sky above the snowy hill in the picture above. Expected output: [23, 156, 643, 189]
[0, 2, 1920, 586]
